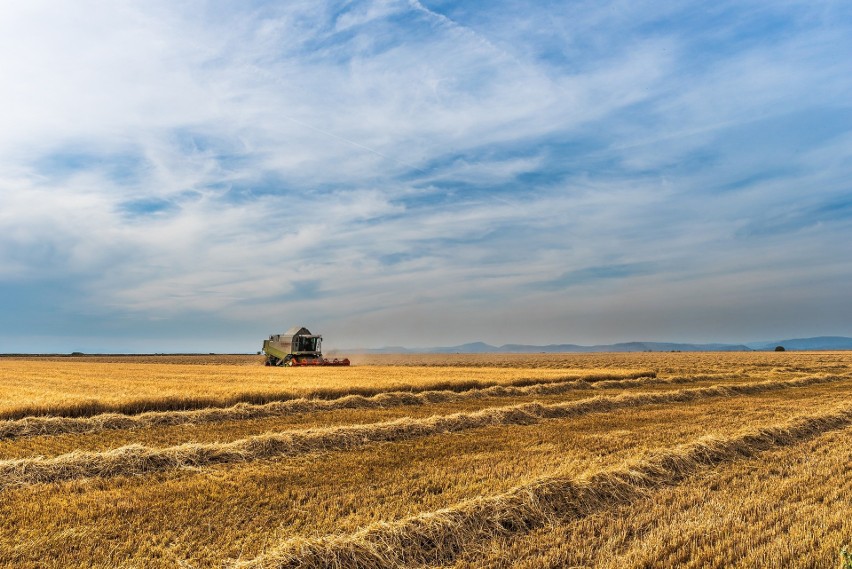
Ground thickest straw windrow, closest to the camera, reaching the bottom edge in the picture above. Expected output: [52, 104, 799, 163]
[232, 406, 852, 569]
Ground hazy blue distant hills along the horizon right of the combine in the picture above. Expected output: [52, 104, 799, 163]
[346, 336, 852, 354]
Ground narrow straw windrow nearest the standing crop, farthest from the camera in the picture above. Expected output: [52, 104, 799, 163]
[0, 368, 738, 439]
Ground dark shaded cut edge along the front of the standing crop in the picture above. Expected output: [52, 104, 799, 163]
[0, 369, 657, 420]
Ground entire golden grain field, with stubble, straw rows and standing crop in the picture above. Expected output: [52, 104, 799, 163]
[0, 352, 852, 568]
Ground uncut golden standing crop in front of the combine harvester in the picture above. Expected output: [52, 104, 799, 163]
[0, 356, 653, 419]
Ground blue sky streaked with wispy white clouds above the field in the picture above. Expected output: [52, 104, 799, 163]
[0, 0, 852, 352]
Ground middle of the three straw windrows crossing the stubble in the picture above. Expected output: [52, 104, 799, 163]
[0, 376, 849, 490]
